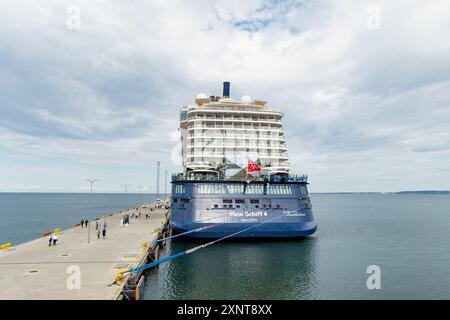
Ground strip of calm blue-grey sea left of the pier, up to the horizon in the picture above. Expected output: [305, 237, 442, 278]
[0, 193, 156, 244]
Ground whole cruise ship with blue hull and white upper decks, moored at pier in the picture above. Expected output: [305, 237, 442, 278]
[171, 82, 317, 238]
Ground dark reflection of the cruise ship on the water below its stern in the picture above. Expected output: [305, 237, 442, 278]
[143, 237, 317, 299]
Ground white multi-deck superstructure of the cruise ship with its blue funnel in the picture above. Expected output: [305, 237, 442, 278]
[180, 82, 289, 174]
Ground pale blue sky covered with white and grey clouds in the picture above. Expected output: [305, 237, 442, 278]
[0, 0, 450, 192]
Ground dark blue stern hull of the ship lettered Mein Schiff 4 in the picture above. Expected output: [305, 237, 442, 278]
[171, 181, 317, 238]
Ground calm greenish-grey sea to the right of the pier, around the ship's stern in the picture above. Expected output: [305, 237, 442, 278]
[144, 194, 450, 299]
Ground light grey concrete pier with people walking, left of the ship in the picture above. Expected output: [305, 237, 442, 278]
[0, 207, 166, 300]
